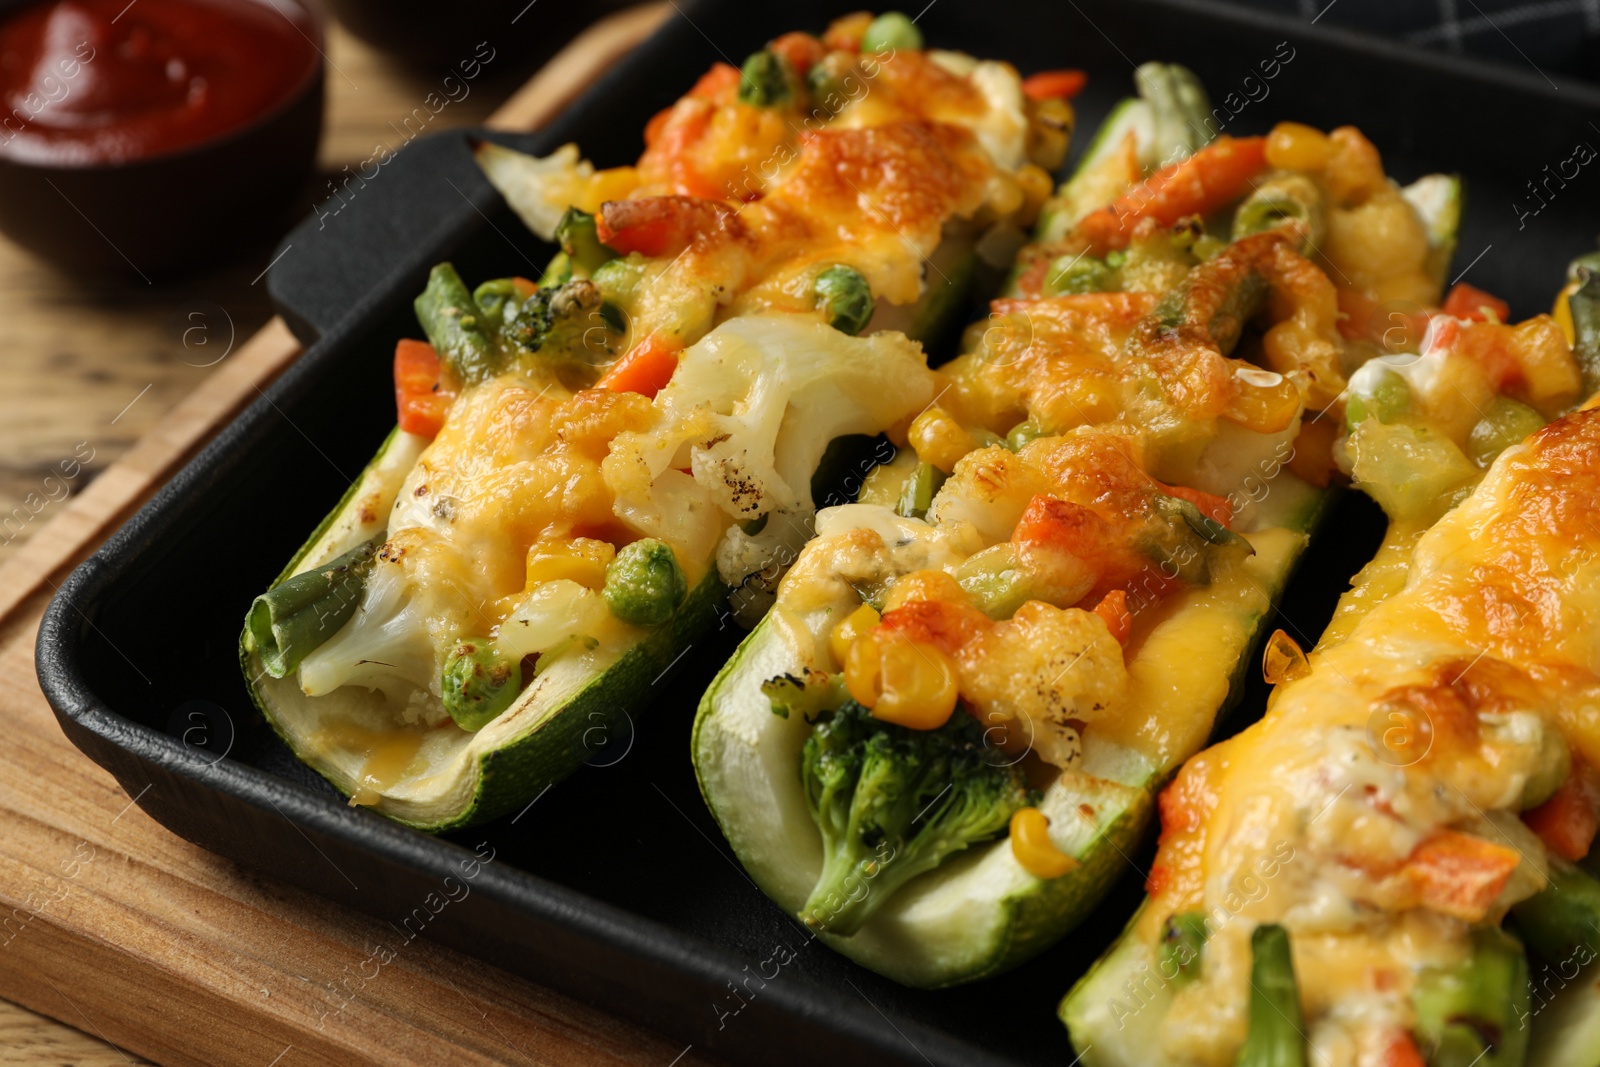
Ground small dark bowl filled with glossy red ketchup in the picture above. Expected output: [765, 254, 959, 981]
[0, 0, 323, 282]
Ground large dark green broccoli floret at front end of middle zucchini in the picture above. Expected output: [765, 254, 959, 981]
[800, 701, 1032, 936]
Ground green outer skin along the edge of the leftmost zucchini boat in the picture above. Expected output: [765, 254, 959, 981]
[238, 430, 728, 833]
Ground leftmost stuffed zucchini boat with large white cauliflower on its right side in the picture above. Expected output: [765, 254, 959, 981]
[240, 16, 1072, 830]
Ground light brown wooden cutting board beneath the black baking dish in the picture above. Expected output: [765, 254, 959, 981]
[0, 5, 709, 1067]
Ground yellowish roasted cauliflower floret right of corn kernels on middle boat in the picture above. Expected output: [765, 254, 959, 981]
[957, 600, 1128, 768]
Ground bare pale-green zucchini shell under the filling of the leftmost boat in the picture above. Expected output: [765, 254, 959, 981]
[238, 429, 726, 832]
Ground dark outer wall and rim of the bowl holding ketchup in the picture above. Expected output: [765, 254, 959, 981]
[0, 0, 323, 280]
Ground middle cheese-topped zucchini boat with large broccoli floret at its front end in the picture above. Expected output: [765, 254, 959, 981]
[693, 95, 1454, 987]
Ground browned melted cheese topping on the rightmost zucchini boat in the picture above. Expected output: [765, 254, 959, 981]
[1141, 411, 1600, 1067]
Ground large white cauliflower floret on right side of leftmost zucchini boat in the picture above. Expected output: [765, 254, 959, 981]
[603, 314, 933, 584]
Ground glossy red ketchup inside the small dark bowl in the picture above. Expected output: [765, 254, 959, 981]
[0, 0, 320, 166]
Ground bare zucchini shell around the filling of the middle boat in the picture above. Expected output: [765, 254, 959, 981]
[691, 479, 1330, 987]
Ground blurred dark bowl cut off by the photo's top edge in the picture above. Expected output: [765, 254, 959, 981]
[326, 0, 637, 69]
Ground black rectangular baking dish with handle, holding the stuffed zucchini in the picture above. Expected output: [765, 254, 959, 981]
[38, 0, 1600, 1067]
